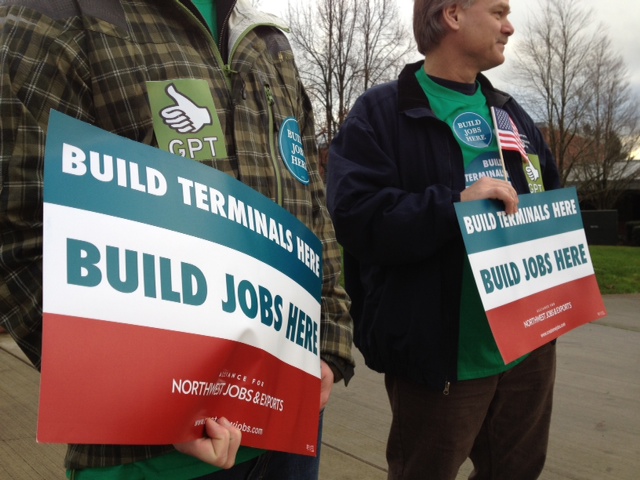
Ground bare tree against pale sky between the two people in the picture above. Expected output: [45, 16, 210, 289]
[287, 0, 413, 143]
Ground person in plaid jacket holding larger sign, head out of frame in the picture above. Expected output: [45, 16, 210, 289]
[0, 0, 354, 480]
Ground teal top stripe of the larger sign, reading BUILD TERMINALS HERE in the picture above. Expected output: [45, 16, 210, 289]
[44, 111, 322, 300]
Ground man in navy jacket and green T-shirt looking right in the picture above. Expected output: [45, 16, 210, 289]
[327, 0, 560, 480]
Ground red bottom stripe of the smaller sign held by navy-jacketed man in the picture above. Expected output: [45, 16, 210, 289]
[487, 275, 607, 364]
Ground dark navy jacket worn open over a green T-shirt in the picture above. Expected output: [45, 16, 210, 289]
[327, 62, 560, 389]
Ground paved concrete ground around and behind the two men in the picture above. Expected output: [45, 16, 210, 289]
[0, 295, 640, 480]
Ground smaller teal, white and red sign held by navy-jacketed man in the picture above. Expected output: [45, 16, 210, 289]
[455, 188, 606, 363]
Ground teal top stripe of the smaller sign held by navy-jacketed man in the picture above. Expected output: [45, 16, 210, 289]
[455, 187, 584, 255]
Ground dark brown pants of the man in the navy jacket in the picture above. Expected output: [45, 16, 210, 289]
[385, 344, 556, 480]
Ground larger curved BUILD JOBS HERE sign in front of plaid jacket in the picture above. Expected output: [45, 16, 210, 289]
[38, 112, 322, 455]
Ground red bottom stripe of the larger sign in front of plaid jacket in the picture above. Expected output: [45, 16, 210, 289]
[38, 313, 320, 455]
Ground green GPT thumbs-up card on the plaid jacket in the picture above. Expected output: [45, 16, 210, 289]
[147, 79, 227, 161]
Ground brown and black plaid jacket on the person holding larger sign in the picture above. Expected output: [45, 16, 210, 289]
[0, 0, 354, 468]
